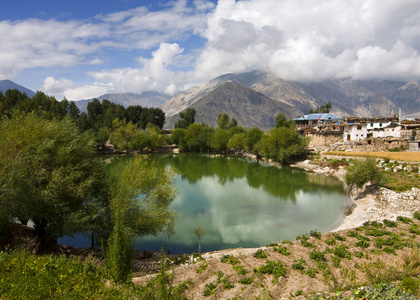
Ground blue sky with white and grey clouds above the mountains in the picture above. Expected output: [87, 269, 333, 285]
[0, 0, 420, 100]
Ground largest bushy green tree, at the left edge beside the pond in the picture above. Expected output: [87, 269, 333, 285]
[0, 112, 107, 251]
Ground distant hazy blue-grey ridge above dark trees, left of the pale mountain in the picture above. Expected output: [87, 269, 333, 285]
[75, 92, 170, 112]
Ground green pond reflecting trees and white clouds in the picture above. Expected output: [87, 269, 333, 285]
[60, 154, 348, 253]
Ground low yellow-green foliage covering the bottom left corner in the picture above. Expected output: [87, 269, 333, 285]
[0, 251, 142, 299]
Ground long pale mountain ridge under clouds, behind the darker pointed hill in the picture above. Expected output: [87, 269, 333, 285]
[160, 71, 420, 128]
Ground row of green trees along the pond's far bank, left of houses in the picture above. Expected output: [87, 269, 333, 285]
[170, 113, 308, 163]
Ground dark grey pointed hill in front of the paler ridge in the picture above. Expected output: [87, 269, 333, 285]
[165, 81, 293, 130]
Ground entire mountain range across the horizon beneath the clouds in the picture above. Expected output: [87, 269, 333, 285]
[0, 71, 420, 130]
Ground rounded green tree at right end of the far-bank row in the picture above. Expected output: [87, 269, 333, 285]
[261, 127, 308, 163]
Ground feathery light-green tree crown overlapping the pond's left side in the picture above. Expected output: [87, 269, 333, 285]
[111, 155, 177, 236]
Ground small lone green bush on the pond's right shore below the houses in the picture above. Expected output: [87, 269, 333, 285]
[346, 159, 380, 191]
